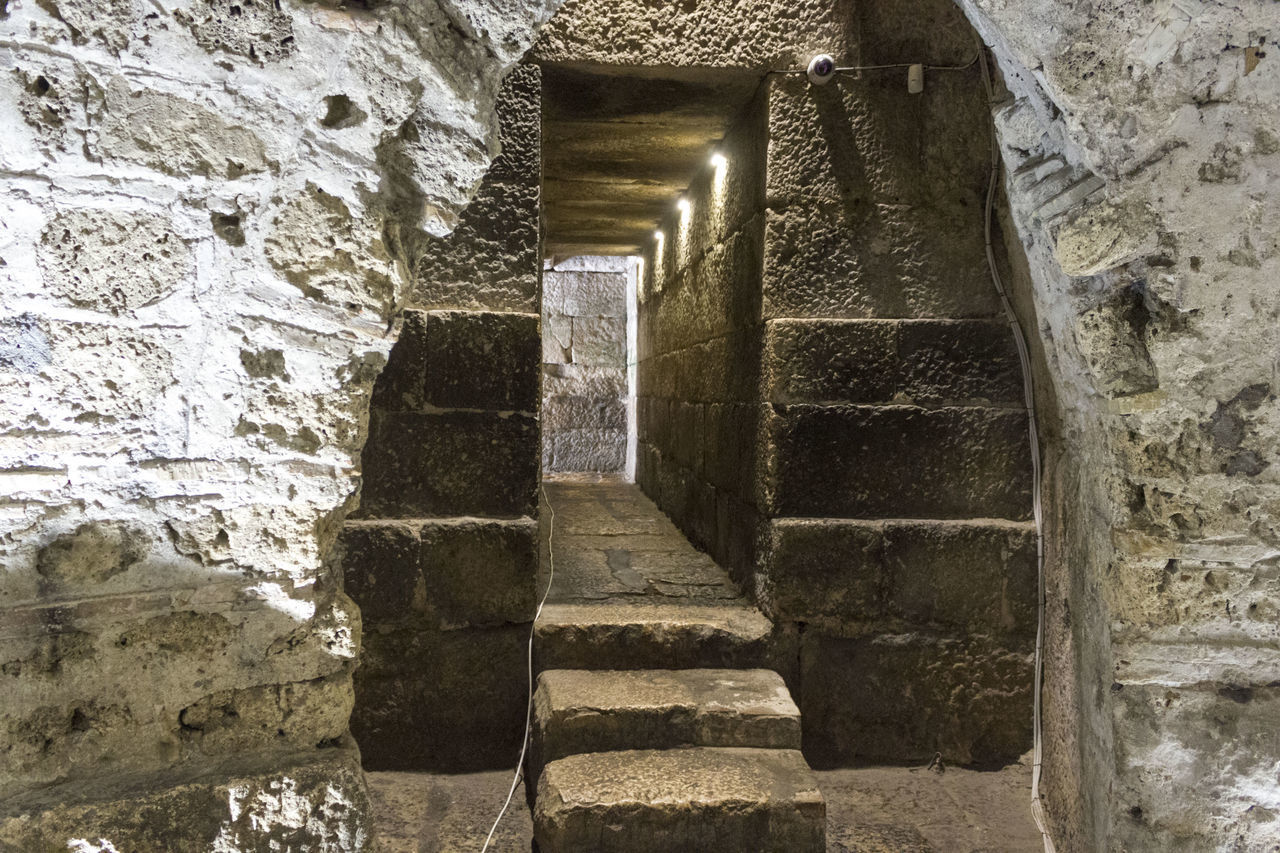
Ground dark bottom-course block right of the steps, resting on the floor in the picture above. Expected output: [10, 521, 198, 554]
[800, 631, 1032, 767]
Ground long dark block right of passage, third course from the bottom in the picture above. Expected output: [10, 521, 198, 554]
[762, 406, 1030, 520]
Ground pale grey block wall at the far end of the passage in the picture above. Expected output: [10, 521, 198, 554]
[543, 256, 630, 474]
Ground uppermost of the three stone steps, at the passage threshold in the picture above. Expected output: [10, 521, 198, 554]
[534, 601, 773, 671]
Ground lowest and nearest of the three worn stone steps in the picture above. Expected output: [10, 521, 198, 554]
[534, 747, 827, 853]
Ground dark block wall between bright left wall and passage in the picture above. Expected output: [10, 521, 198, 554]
[343, 67, 541, 770]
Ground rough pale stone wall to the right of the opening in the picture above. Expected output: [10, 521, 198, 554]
[960, 0, 1280, 850]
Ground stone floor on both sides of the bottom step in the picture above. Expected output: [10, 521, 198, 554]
[369, 765, 1041, 853]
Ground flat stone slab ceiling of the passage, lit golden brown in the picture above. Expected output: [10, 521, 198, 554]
[543, 65, 760, 256]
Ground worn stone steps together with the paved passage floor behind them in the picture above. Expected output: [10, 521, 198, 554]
[526, 483, 826, 853]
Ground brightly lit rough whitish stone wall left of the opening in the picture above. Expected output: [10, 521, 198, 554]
[0, 0, 556, 850]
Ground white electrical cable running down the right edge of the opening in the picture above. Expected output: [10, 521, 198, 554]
[978, 46, 1055, 853]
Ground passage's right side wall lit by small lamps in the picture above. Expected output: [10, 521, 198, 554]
[636, 84, 765, 581]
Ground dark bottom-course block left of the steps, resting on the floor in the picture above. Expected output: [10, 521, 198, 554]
[351, 625, 529, 772]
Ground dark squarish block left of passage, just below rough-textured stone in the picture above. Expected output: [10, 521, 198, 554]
[424, 311, 541, 414]
